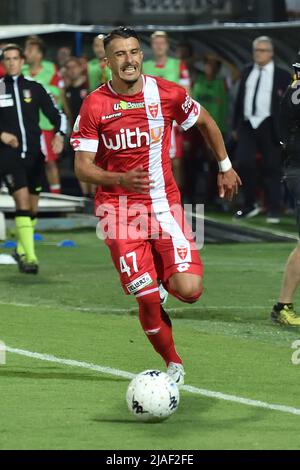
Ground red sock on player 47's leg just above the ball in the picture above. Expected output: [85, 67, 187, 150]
[137, 292, 182, 365]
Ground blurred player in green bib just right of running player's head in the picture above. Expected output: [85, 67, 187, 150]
[143, 31, 191, 189]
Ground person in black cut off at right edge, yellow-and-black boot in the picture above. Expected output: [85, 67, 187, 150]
[271, 54, 300, 326]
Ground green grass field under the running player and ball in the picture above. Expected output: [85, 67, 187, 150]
[0, 231, 300, 450]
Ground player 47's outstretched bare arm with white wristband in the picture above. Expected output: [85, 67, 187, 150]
[196, 106, 242, 201]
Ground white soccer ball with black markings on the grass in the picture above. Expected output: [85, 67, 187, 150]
[126, 370, 179, 422]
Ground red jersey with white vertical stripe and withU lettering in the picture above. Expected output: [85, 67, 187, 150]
[71, 75, 201, 212]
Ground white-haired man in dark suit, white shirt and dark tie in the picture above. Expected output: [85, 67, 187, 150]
[234, 36, 290, 223]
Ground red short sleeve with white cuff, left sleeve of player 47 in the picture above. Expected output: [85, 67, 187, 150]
[70, 95, 99, 152]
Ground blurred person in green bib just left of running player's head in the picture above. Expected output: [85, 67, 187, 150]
[88, 34, 111, 91]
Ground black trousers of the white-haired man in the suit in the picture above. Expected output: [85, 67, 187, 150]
[236, 118, 282, 216]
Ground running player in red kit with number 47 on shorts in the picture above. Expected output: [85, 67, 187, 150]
[71, 27, 241, 385]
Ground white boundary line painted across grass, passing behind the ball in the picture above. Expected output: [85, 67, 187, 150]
[6, 346, 300, 416]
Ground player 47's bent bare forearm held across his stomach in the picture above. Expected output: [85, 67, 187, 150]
[75, 151, 151, 194]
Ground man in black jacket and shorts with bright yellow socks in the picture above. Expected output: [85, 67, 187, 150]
[0, 44, 66, 274]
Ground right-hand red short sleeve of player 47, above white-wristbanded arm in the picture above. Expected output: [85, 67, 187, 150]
[172, 86, 201, 131]
